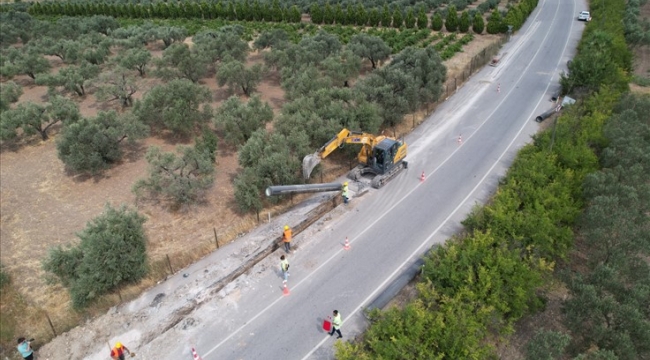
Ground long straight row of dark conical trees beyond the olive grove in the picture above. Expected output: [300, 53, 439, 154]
[21, 0, 506, 32]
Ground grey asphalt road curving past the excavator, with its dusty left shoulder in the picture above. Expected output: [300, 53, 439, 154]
[176, 0, 586, 360]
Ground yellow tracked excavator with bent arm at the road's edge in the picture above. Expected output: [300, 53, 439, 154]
[302, 129, 408, 189]
